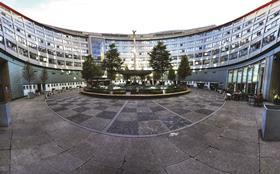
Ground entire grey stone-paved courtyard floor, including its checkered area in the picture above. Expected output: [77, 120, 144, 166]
[0, 89, 280, 174]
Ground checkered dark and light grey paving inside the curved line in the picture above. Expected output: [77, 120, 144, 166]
[47, 89, 224, 137]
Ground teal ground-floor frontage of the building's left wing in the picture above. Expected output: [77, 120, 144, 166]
[0, 50, 84, 101]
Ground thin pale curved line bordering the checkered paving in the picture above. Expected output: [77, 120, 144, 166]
[45, 94, 226, 138]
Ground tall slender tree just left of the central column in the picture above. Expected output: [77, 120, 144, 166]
[102, 44, 123, 83]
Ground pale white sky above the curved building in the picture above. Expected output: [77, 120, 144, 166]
[0, 0, 270, 34]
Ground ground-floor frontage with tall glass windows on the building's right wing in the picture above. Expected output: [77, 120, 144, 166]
[187, 44, 280, 100]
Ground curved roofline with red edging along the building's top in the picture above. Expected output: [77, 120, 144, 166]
[0, 0, 279, 40]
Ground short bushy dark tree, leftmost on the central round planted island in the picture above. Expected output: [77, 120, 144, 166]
[81, 56, 103, 86]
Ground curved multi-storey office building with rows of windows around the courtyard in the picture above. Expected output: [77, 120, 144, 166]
[0, 0, 280, 99]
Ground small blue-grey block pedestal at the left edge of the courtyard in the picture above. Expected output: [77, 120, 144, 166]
[0, 103, 12, 127]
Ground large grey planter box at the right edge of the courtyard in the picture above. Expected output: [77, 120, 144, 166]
[262, 105, 280, 141]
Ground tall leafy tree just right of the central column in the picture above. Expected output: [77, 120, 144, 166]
[149, 42, 171, 83]
